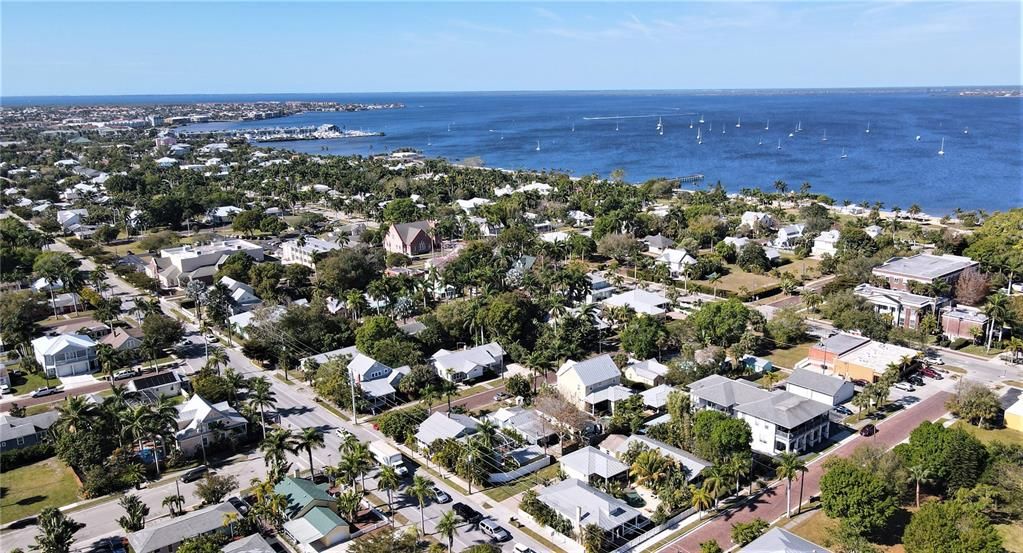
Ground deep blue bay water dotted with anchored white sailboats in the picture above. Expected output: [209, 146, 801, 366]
[85, 91, 1023, 215]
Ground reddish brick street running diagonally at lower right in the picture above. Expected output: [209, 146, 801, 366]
[660, 393, 949, 553]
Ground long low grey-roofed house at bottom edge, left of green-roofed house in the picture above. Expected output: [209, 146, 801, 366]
[128, 502, 241, 553]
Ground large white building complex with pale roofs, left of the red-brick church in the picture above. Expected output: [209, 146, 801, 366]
[146, 238, 263, 288]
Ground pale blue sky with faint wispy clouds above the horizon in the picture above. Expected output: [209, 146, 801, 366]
[0, 0, 1021, 96]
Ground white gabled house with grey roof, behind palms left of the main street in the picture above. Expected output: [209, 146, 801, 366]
[174, 394, 249, 456]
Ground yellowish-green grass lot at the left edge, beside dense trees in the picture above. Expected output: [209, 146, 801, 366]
[0, 457, 78, 523]
